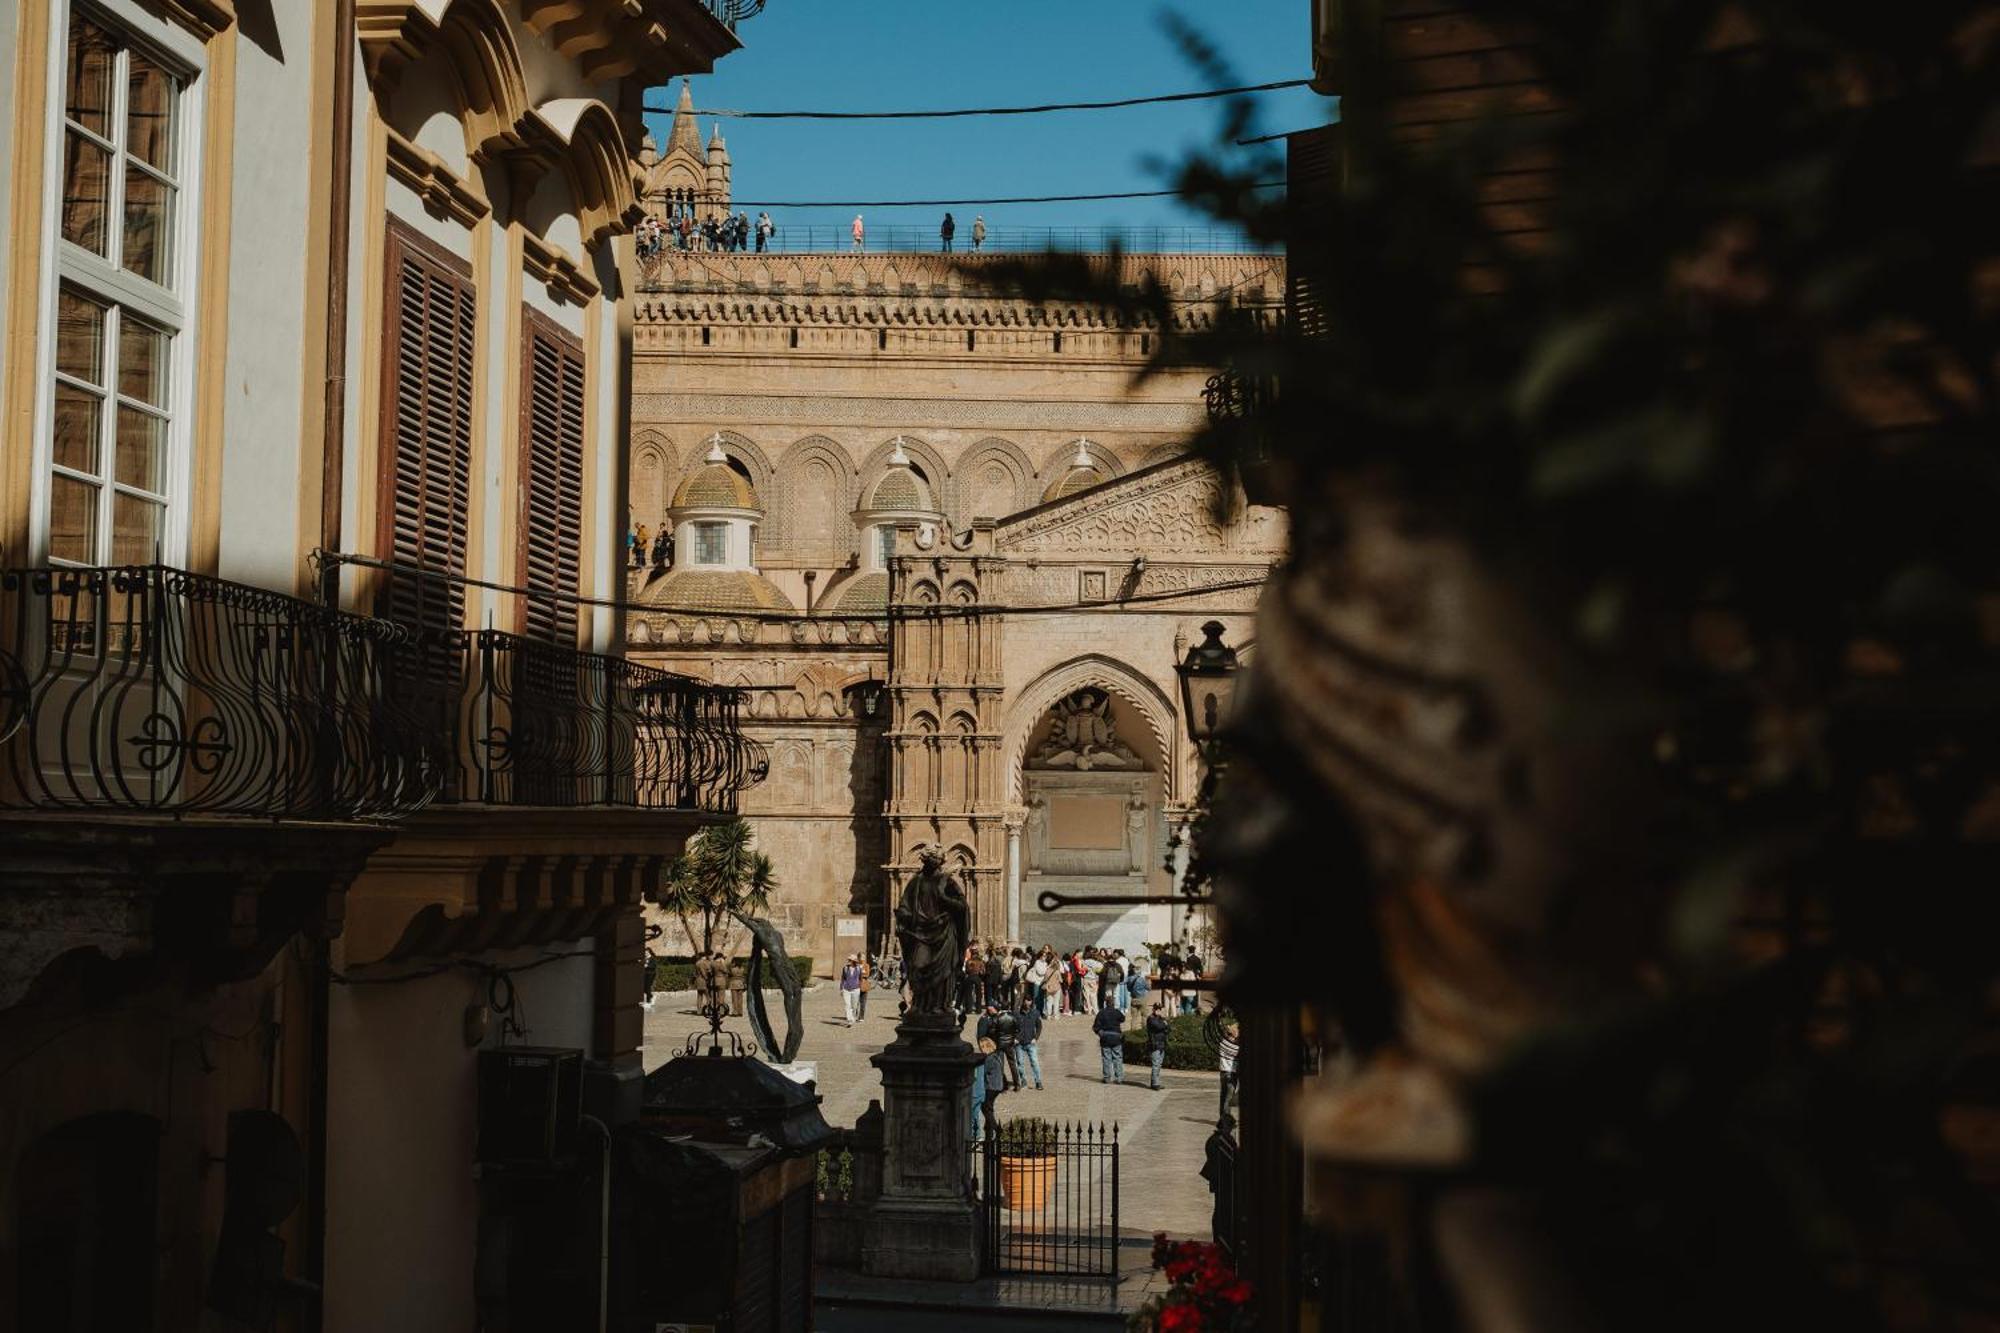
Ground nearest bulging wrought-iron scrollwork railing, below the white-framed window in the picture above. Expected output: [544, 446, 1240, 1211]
[0, 564, 446, 819]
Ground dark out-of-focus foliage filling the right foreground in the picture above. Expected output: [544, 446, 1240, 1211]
[1010, 0, 2000, 1329]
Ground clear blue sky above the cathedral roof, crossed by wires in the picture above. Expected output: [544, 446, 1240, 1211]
[648, 0, 1332, 242]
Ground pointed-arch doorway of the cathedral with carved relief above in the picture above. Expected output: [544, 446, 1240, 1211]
[1008, 662, 1172, 951]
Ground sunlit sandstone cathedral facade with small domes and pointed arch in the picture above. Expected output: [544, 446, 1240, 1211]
[626, 93, 1284, 969]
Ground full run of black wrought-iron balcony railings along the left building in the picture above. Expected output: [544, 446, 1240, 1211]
[0, 564, 764, 823]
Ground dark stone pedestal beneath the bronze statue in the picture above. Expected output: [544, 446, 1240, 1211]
[862, 1015, 984, 1281]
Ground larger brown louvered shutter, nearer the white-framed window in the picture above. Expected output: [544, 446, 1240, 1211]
[378, 222, 478, 644]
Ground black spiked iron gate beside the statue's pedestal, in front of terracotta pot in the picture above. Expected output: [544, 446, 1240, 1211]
[970, 1121, 1118, 1277]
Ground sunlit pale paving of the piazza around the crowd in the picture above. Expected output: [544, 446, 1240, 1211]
[644, 981, 1216, 1239]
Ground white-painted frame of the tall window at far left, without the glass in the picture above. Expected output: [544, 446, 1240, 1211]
[28, 0, 206, 564]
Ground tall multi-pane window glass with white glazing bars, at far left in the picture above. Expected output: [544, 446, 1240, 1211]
[48, 12, 186, 564]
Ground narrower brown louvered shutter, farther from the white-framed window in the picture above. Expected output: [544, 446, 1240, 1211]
[520, 310, 584, 648]
